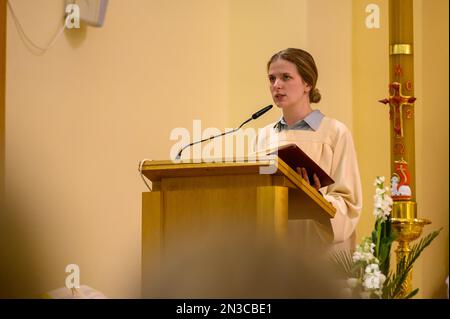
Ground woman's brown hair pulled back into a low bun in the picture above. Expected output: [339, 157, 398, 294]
[267, 48, 322, 103]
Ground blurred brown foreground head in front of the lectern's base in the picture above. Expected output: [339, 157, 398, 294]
[143, 222, 339, 298]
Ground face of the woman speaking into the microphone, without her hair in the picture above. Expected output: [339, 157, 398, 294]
[268, 59, 311, 109]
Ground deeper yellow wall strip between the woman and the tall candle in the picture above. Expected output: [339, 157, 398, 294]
[352, 0, 390, 264]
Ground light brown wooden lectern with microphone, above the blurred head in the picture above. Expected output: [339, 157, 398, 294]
[142, 157, 335, 296]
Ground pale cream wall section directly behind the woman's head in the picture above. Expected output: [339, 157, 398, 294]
[230, 0, 353, 134]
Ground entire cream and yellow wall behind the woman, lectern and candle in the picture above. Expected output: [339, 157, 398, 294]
[6, 0, 448, 297]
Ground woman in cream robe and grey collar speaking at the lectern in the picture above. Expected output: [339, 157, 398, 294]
[256, 48, 362, 252]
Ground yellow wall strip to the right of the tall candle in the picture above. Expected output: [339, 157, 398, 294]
[413, 0, 449, 298]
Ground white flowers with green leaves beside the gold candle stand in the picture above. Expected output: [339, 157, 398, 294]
[332, 176, 440, 299]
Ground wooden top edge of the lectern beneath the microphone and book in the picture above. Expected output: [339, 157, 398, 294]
[141, 156, 336, 217]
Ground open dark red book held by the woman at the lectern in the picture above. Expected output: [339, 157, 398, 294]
[268, 144, 334, 187]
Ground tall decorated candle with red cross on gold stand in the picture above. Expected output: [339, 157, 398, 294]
[380, 0, 431, 296]
